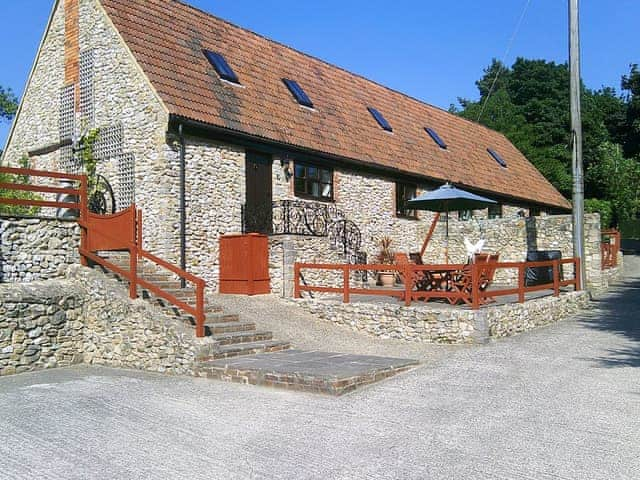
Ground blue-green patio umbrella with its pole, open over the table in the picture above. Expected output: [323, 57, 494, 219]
[407, 183, 498, 262]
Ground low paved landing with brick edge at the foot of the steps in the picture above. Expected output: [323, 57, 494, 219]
[197, 350, 418, 395]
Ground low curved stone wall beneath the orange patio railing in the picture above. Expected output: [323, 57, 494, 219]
[292, 292, 589, 344]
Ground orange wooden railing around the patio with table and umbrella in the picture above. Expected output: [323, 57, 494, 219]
[294, 258, 582, 309]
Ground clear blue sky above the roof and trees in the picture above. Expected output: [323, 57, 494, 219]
[0, 0, 640, 145]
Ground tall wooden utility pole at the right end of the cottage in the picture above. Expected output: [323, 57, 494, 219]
[569, 0, 586, 288]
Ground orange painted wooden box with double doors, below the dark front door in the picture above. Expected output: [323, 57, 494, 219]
[220, 233, 271, 295]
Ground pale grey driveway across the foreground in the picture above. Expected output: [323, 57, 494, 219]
[0, 258, 640, 480]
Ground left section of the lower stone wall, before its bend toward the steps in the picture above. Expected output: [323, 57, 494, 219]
[0, 280, 84, 375]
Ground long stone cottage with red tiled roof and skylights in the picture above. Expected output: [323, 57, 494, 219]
[3, 0, 580, 291]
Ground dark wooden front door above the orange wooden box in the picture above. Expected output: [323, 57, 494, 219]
[244, 152, 272, 235]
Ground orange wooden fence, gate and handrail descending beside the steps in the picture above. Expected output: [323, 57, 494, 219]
[0, 167, 206, 337]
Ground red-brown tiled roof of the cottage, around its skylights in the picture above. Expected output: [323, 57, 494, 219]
[101, 0, 570, 208]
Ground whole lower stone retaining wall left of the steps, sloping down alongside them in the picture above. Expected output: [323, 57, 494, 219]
[0, 266, 218, 375]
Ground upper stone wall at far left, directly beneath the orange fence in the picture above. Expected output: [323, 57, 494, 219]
[0, 217, 80, 283]
